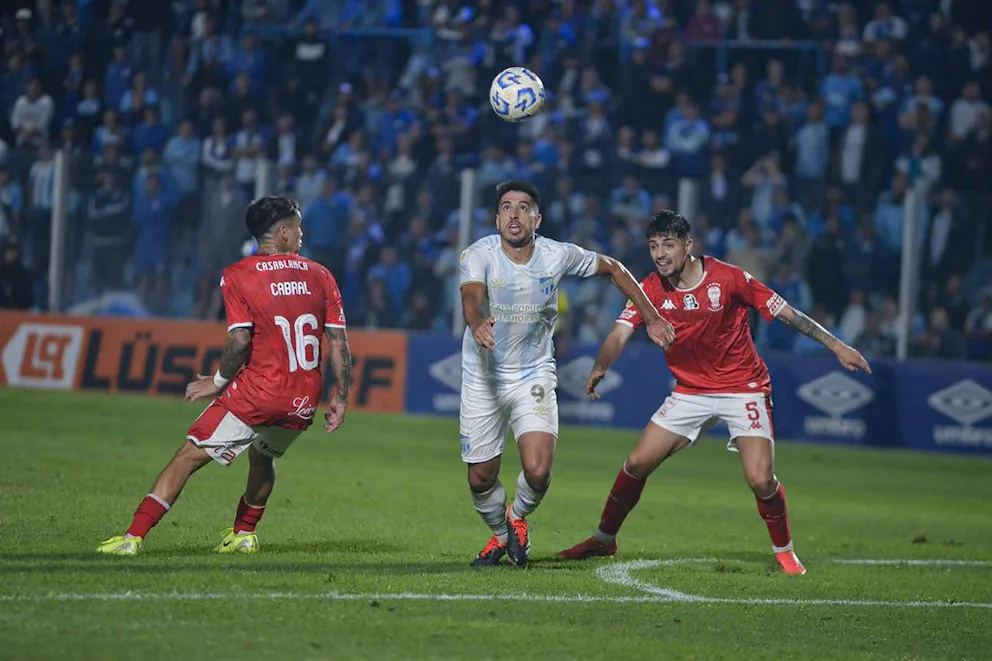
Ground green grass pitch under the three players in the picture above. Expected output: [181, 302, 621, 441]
[0, 390, 992, 661]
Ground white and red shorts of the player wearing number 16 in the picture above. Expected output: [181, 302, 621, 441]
[186, 400, 303, 466]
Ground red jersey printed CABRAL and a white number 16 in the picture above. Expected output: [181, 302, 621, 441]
[220, 255, 345, 430]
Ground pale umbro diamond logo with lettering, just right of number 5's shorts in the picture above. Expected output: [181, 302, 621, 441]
[797, 372, 875, 439]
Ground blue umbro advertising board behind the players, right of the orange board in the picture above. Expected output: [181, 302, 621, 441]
[406, 335, 992, 453]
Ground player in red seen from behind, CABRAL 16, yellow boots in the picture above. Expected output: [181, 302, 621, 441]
[97, 196, 351, 555]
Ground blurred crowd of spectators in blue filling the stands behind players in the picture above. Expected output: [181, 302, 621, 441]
[0, 0, 992, 359]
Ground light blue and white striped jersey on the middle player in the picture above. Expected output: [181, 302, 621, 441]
[459, 234, 599, 389]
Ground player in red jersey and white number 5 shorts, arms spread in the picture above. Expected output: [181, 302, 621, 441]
[560, 211, 871, 575]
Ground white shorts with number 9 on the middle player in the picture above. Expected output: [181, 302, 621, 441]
[458, 376, 558, 464]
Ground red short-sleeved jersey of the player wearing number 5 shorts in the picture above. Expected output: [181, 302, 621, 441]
[617, 257, 786, 395]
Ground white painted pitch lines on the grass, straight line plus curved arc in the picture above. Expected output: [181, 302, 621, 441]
[0, 558, 992, 608]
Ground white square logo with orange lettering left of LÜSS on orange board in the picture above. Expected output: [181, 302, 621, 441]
[0, 323, 84, 390]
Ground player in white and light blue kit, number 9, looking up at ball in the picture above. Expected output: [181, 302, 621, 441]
[459, 181, 675, 567]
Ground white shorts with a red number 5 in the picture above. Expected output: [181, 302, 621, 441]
[651, 392, 775, 450]
